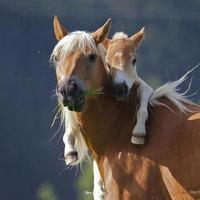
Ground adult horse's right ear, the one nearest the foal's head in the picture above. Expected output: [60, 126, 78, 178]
[92, 18, 111, 44]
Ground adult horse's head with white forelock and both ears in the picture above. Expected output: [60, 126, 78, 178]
[52, 17, 111, 111]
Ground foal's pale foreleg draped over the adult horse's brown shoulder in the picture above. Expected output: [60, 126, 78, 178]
[131, 79, 153, 144]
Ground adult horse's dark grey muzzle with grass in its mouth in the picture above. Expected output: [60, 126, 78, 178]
[56, 78, 85, 112]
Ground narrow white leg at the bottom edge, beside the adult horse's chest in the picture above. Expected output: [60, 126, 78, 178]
[93, 160, 105, 200]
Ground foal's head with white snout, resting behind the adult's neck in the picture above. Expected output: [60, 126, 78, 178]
[106, 28, 144, 100]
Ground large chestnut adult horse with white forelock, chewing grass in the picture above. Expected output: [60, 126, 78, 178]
[52, 17, 200, 200]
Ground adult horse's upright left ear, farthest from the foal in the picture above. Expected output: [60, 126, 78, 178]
[53, 16, 68, 41]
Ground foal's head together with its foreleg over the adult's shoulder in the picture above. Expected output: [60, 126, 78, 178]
[106, 28, 153, 144]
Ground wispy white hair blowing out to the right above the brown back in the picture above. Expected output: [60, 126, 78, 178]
[150, 63, 200, 112]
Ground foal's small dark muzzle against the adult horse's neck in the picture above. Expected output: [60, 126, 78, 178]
[113, 82, 129, 101]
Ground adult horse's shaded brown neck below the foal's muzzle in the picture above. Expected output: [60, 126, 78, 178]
[79, 72, 138, 159]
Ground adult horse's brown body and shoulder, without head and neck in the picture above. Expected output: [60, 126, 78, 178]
[104, 101, 200, 200]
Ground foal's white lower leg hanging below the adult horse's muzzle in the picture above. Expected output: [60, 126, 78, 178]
[63, 126, 78, 165]
